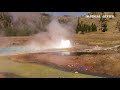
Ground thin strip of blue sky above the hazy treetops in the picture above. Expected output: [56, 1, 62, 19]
[43, 12, 87, 16]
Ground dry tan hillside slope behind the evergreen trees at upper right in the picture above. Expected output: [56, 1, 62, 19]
[80, 12, 120, 33]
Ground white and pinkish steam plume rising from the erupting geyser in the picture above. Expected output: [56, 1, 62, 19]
[29, 19, 73, 50]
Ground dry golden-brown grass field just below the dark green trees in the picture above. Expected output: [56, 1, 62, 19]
[74, 32, 120, 46]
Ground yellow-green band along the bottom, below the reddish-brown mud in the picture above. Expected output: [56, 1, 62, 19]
[0, 56, 100, 78]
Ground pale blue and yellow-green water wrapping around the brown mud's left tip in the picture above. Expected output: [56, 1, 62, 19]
[0, 46, 101, 78]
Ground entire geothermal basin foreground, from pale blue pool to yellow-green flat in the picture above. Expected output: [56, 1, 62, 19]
[0, 46, 120, 77]
